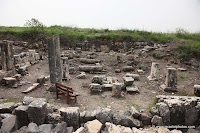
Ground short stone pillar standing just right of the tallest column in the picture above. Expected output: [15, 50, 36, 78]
[61, 57, 70, 80]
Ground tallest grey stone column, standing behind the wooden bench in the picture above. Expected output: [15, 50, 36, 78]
[48, 36, 62, 84]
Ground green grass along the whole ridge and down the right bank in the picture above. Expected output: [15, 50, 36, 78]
[0, 25, 200, 59]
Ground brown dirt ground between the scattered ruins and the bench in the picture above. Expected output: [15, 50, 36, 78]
[0, 45, 200, 110]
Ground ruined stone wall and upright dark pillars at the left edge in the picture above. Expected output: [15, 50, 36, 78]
[0, 40, 41, 88]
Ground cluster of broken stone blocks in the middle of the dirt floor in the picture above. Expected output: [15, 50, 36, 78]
[89, 73, 139, 98]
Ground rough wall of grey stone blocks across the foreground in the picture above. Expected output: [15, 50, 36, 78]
[0, 95, 200, 133]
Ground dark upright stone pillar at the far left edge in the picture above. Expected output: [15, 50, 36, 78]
[0, 40, 14, 72]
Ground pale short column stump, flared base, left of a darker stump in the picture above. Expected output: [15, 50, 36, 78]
[147, 62, 159, 80]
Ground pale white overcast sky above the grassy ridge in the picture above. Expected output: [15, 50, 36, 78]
[0, 0, 200, 32]
